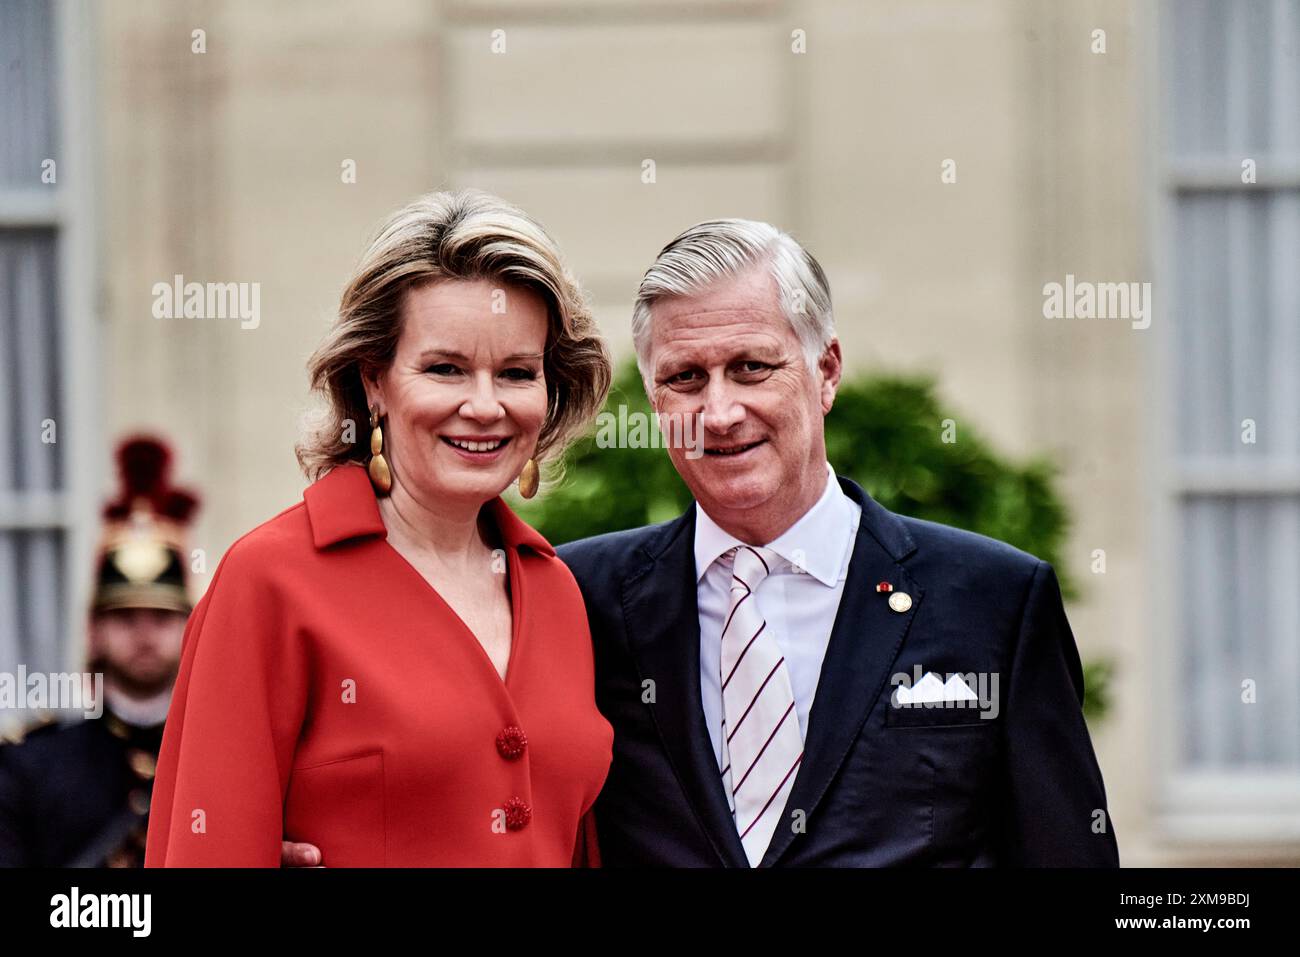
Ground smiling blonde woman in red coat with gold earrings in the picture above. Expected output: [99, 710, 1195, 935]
[146, 190, 612, 867]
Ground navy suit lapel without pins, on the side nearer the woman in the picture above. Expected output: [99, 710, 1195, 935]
[623, 506, 749, 867]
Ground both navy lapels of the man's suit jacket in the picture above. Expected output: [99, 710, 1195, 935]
[623, 476, 924, 867]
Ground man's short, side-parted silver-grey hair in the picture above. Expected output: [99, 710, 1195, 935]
[632, 220, 835, 389]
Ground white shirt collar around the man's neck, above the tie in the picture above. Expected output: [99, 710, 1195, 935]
[696, 462, 859, 588]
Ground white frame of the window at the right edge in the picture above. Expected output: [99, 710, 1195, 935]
[1136, 0, 1300, 837]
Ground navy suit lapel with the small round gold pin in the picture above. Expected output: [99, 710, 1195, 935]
[759, 477, 924, 866]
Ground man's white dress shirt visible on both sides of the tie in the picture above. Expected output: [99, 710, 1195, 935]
[696, 462, 862, 770]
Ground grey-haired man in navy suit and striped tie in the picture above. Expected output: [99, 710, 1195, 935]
[558, 220, 1118, 867]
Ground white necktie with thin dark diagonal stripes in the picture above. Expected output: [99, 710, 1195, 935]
[719, 545, 803, 867]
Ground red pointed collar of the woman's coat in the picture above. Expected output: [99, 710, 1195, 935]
[303, 464, 555, 555]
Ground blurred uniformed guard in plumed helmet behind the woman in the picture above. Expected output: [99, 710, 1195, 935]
[0, 437, 198, 867]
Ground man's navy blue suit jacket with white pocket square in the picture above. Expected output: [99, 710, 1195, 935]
[558, 477, 1119, 867]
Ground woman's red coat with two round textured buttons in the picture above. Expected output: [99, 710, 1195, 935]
[146, 465, 614, 867]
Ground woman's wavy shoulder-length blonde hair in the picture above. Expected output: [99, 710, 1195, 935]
[295, 189, 611, 481]
